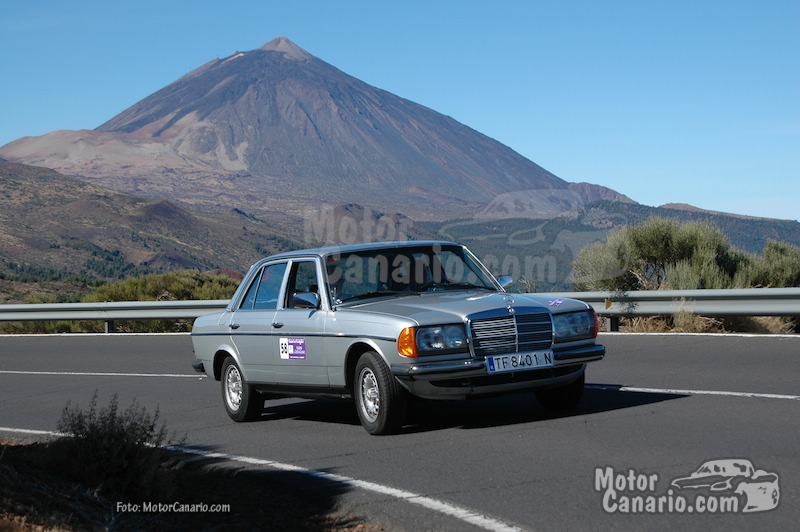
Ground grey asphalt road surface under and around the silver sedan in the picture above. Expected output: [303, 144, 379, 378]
[0, 334, 800, 531]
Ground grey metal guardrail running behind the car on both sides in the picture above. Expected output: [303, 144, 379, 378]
[0, 288, 800, 332]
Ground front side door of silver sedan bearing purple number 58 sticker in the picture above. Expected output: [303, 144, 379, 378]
[273, 258, 328, 387]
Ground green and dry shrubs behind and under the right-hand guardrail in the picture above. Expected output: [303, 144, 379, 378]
[572, 217, 800, 333]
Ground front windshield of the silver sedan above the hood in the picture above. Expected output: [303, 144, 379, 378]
[325, 245, 498, 305]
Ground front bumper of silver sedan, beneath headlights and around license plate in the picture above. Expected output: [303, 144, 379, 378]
[391, 344, 606, 399]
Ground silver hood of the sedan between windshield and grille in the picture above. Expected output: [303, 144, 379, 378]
[340, 290, 589, 325]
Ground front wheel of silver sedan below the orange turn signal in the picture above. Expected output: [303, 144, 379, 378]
[353, 351, 408, 435]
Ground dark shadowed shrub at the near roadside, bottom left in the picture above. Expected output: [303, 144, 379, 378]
[54, 392, 182, 500]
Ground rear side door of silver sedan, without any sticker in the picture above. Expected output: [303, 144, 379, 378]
[229, 261, 288, 383]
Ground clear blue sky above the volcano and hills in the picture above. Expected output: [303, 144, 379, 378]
[0, 0, 800, 220]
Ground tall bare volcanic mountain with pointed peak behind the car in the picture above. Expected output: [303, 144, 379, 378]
[0, 37, 632, 220]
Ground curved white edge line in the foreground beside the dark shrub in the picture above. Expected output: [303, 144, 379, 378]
[0, 427, 522, 532]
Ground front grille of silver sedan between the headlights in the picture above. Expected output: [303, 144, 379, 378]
[470, 311, 553, 357]
